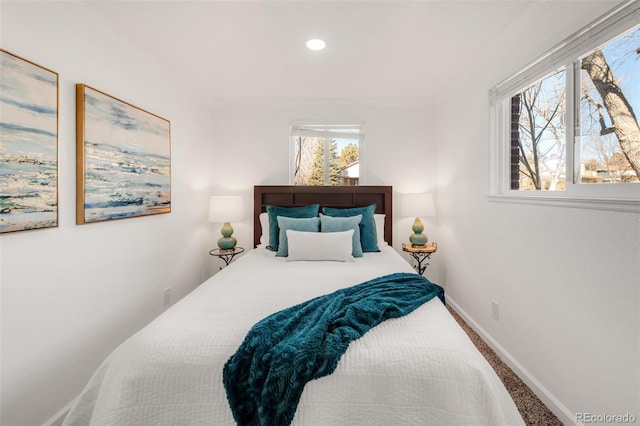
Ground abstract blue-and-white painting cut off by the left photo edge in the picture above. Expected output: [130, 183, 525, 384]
[0, 49, 58, 233]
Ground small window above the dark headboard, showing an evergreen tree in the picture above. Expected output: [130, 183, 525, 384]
[290, 121, 364, 186]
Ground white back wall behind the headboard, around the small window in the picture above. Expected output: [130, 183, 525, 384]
[205, 99, 441, 276]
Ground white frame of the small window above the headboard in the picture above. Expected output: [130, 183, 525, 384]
[289, 120, 366, 185]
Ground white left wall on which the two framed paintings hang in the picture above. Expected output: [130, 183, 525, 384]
[0, 2, 221, 426]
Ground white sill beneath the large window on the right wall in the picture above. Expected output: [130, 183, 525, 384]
[488, 194, 640, 213]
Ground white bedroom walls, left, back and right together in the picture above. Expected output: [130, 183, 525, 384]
[0, 2, 640, 426]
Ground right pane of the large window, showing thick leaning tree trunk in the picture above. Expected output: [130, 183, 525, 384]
[576, 28, 640, 186]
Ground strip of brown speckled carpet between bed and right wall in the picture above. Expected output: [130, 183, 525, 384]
[447, 306, 562, 426]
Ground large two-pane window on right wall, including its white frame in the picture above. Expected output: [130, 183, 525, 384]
[490, 2, 640, 211]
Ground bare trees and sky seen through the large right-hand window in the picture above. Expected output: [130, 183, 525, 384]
[510, 28, 640, 191]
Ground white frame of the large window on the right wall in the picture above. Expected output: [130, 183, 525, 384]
[489, 0, 640, 212]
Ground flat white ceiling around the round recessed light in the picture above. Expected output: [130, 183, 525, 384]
[85, 0, 620, 98]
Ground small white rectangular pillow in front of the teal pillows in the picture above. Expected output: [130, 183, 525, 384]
[286, 229, 353, 262]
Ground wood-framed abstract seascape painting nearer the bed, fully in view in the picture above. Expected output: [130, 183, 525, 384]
[76, 84, 171, 224]
